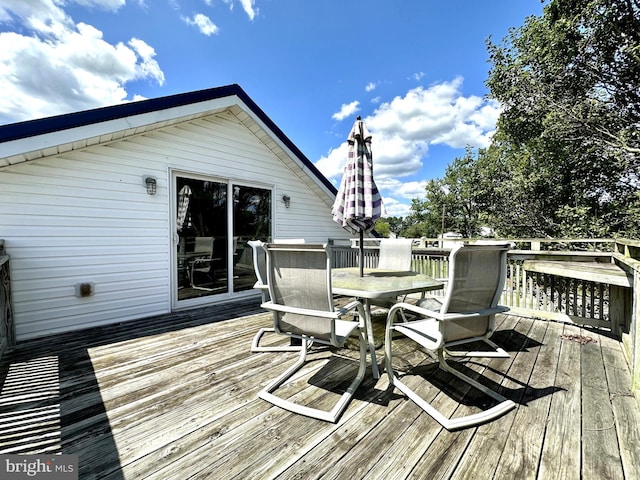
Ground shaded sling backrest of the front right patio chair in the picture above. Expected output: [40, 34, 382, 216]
[440, 243, 512, 342]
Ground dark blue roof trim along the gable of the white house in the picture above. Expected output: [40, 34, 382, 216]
[0, 83, 338, 195]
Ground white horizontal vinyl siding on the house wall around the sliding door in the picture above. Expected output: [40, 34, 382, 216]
[0, 112, 348, 340]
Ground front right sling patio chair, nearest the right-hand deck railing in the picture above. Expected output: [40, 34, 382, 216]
[385, 244, 515, 430]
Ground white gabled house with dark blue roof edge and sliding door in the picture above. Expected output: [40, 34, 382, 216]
[0, 85, 348, 340]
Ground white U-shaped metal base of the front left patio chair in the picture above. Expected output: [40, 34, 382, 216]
[258, 331, 367, 423]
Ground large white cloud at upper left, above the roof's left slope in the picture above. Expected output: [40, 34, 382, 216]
[0, 0, 164, 123]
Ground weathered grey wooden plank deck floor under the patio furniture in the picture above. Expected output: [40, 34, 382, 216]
[0, 302, 640, 480]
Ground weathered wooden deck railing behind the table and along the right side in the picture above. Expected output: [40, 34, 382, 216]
[333, 238, 640, 391]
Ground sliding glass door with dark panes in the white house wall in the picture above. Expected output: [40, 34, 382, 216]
[174, 175, 272, 304]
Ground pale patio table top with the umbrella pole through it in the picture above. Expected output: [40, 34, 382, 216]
[331, 267, 444, 298]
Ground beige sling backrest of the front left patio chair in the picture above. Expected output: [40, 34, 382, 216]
[264, 243, 335, 341]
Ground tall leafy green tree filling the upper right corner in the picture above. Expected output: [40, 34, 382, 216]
[478, 0, 640, 236]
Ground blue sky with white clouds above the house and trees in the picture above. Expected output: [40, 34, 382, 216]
[0, 0, 544, 216]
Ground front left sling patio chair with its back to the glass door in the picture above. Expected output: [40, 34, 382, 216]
[258, 244, 367, 422]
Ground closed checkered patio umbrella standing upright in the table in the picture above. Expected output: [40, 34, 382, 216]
[331, 117, 384, 276]
